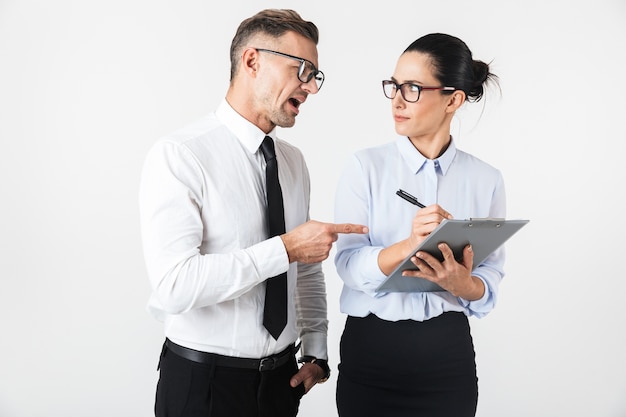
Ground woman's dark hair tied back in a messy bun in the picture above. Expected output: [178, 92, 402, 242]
[404, 33, 498, 102]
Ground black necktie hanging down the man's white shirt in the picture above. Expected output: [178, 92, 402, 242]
[261, 136, 287, 339]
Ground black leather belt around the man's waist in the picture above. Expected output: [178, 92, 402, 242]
[165, 339, 300, 372]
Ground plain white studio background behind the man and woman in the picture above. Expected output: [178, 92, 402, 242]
[0, 0, 626, 417]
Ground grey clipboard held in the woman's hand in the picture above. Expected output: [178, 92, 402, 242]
[376, 218, 529, 292]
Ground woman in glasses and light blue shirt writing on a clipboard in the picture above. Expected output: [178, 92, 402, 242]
[335, 33, 505, 417]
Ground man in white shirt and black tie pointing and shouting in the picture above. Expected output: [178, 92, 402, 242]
[139, 9, 367, 417]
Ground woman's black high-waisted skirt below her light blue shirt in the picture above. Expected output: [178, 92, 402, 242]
[337, 312, 478, 417]
